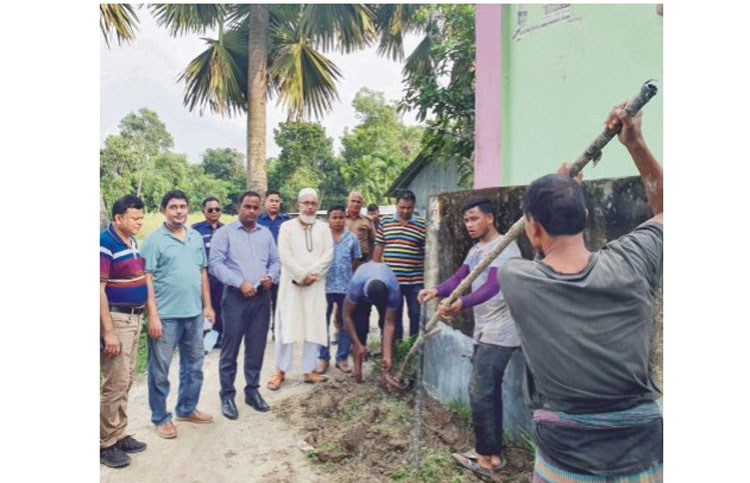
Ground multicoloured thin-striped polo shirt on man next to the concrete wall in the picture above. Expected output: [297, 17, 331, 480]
[375, 216, 427, 285]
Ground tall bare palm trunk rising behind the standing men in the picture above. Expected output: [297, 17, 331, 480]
[247, 5, 268, 194]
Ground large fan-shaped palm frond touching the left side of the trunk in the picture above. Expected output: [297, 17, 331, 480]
[177, 26, 248, 116]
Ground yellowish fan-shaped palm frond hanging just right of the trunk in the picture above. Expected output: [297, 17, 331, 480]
[269, 23, 341, 119]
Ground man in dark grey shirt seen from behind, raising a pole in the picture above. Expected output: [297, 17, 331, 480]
[498, 103, 663, 482]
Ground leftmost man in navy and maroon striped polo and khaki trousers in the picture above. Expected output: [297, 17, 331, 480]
[99, 195, 148, 468]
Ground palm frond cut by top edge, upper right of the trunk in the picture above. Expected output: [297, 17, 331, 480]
[299, 4, 376, 53]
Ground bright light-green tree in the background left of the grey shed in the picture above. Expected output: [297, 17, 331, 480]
[341, 88, 422, 204]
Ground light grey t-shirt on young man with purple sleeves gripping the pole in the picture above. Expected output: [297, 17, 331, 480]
[464, 236, 521, 347]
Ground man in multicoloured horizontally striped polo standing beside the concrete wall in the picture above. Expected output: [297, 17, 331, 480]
[373, 190, 427, 340]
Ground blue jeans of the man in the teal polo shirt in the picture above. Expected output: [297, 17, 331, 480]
[148, 314, 203, 426]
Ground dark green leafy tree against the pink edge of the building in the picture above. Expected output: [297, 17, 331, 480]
[401, 4, 476, 187]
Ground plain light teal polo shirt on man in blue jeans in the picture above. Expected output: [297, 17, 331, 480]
[143, 224, 208, 319]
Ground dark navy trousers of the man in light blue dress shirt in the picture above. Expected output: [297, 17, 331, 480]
[219, 287, 271, 399]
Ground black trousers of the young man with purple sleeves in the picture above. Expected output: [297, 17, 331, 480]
[469, 342, 518, 456]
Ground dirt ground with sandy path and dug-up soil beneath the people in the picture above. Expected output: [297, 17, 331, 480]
[100, 311, 533, 483]
